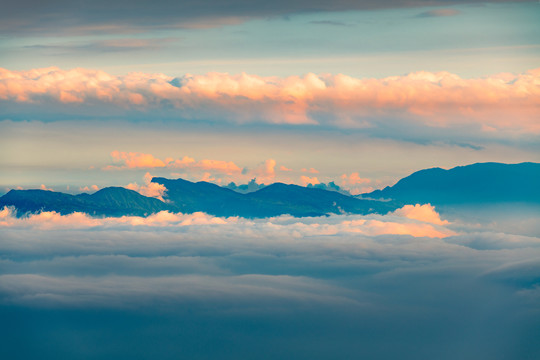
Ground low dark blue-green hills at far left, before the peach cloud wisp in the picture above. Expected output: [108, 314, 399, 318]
[0, 187, 170, 216]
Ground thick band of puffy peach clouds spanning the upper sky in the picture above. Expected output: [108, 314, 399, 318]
[4, 68, 540, 135]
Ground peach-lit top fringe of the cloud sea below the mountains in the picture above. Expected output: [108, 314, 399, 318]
[0, 202, 456, 238]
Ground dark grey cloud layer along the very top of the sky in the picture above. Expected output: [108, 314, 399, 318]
[0, 0, 524, 35]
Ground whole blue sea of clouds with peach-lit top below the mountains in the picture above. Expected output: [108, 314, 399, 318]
[0, 205, 540, 359]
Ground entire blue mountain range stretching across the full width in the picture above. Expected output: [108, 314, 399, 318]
[0, 163, 540, 218]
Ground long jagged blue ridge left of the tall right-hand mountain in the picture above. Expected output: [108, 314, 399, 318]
[0, 178, 395, 218]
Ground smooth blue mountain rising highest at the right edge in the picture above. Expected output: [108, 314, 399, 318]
[360, 163, 540, 206]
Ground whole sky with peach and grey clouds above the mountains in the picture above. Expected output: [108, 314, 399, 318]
[0, 0, 540, 193]
